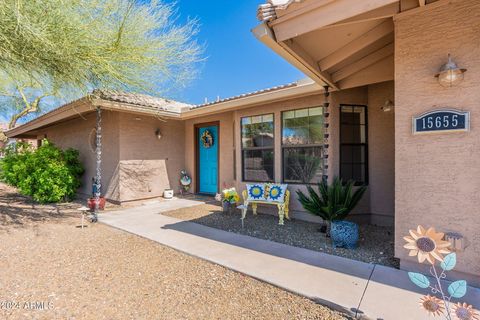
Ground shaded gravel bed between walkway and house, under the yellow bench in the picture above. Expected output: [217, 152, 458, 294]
[162, 202, 399, 268]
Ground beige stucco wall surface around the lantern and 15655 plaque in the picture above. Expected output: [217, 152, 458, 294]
[395, 0, 480, 284]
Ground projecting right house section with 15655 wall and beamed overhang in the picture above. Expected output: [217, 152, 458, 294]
[253, 0, 480, 286]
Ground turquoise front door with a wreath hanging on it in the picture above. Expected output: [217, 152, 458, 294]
[198, 126, 218, 194]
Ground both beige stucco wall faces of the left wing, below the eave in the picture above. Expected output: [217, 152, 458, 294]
[33, 110, 185, 202]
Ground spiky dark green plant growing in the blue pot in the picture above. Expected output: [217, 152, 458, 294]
[297, 177, 367, 236]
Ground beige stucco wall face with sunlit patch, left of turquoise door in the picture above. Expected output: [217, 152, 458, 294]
[116, 113, 185, 202]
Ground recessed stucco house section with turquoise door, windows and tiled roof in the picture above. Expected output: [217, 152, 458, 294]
[7, 79, 394, 225]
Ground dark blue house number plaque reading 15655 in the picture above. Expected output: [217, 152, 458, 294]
[412, 109, 470, 134]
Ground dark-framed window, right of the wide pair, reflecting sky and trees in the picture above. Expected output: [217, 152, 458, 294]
[282, 107, 324, 184]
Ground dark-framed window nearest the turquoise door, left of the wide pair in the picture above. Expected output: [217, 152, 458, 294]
[241, 113, 275, 182]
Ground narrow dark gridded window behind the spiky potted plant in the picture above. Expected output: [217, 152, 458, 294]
[340, 105, 368, 185]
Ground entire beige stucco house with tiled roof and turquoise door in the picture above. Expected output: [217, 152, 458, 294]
[6, 0, 480, 286]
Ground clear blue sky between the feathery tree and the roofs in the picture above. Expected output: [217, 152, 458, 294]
[171, 0, 304, 103]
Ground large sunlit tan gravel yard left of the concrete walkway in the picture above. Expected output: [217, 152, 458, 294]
[0, 184, 347, 320]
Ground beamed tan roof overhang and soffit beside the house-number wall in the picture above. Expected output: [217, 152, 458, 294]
[258, 0, 444, 89]
